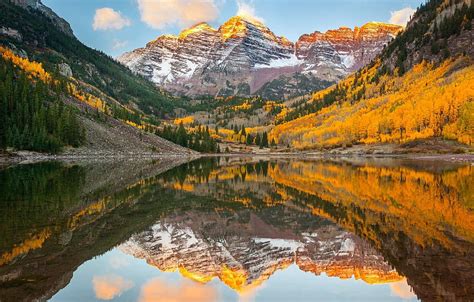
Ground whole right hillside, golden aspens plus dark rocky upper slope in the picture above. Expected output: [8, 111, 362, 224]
[270, 0, 474, 149]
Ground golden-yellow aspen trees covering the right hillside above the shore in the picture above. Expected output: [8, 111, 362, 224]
[270, 57, 474, 149]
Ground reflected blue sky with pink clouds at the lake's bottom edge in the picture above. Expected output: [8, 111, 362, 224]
[51, 249, 416, 302]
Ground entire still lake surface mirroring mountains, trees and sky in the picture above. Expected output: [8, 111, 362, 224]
[0, 158, 474, 301]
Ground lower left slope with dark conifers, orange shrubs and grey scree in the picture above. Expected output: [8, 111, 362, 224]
[0, 46, 194, 155]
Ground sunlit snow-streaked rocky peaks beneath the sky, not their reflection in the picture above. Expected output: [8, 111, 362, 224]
[118, 16, 401, 98]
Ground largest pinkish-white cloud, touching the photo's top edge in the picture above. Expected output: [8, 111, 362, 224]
[137, 0, 219, 29]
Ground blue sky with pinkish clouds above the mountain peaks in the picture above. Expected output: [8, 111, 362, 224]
[43, 0, 424, 56]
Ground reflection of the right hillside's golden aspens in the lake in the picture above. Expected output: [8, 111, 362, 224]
[269, 162, 474, 247]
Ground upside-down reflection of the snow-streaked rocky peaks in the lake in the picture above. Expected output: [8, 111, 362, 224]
[120, 212, 402, 291]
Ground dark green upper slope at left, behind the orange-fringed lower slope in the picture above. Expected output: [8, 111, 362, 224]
[0, 0, 190, 117]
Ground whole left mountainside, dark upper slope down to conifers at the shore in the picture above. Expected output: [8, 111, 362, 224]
[0, 1, 206, 154]
